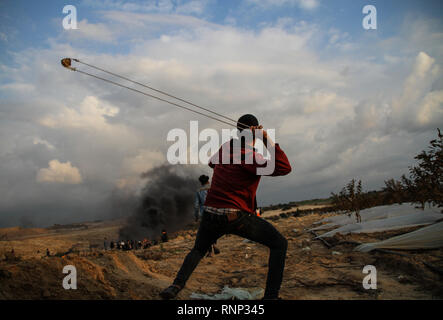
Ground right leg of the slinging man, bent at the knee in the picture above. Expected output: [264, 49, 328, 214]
[230, 215, 288, 299]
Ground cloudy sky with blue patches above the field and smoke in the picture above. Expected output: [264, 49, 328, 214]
[0, 0, 443, 226]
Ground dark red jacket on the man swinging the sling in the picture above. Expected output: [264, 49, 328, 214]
[205, 140, 291, 213]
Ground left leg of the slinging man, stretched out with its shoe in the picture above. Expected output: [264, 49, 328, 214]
[161, 213, 221, 299]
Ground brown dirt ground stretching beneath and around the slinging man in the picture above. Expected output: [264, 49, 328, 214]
[0, 213, 443, 300]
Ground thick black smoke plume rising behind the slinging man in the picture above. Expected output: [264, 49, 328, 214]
[119, 164, 199, 239]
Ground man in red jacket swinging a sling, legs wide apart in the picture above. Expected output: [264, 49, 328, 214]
[160, 114, 291, 300]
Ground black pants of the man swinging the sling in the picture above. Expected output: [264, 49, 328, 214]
[174, 212, 288, 298]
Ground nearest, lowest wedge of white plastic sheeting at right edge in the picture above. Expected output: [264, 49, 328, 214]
[354, 221, 443, 252]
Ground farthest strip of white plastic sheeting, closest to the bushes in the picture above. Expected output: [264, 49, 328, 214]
[310, 203, 440, 231]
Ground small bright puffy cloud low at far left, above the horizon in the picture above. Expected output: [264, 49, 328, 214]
[36, 159, 83, 184]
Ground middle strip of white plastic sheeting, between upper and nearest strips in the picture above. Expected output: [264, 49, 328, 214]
[318, 212, 443, 238]
